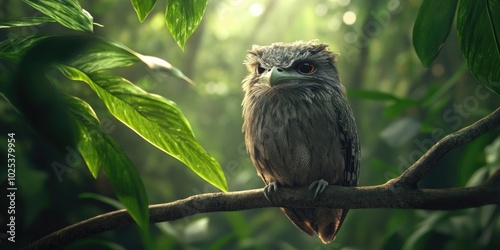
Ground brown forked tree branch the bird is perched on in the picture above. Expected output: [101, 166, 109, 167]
[23, 108, 500, 249]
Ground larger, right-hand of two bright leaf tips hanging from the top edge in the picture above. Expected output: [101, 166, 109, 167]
[165, 0, 207, 49]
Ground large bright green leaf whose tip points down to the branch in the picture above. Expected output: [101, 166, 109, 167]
[59, 66, 227, 191]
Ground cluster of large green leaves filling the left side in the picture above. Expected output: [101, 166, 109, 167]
[0, 0, 227, 248]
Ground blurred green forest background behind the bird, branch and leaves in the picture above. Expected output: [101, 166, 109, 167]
[0, 0, 500, 249]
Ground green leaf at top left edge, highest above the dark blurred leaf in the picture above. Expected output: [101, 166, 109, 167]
[23, 0, 93, 32]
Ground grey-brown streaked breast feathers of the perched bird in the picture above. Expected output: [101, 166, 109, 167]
[244, 92, 344, 186]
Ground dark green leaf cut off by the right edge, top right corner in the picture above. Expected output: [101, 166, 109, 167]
[457, 0, 500, 95]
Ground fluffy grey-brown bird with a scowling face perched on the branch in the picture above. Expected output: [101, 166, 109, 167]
[242, 40, 360, 244]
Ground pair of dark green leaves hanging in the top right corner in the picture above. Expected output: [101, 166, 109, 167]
[413, 0, 500, 95]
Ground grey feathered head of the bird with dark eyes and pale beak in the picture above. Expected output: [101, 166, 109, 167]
[243, 41, 340, 92]
